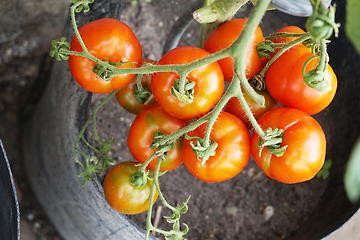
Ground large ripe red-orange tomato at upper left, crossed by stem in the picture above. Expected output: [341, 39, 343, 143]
[69, 18, 142, 93]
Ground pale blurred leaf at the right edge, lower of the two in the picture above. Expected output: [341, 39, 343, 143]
[344, 138, 360, 203]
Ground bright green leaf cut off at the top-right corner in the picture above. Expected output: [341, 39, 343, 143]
[345, 0, 360, 54]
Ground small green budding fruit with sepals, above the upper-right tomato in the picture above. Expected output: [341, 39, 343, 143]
[306, 0, 339, 39]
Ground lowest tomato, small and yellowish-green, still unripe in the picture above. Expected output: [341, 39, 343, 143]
[104, 161, 158, 214]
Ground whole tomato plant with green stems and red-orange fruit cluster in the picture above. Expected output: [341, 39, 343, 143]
[51, 0, 337, 239]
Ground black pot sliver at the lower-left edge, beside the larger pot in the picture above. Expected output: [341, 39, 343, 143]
[0, 139, 20, 240]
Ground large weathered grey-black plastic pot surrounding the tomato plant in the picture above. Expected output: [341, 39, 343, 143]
[22, 0, 360, 240]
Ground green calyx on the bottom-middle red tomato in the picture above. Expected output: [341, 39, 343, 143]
[185, 134, 218, 166]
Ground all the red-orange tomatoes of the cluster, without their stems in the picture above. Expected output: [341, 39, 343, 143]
[69, 19, 337, 214]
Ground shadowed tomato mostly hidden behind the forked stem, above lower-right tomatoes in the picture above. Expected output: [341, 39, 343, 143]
[225, 90, 277, 130]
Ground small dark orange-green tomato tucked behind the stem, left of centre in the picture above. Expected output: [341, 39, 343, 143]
[115, 59, 157, 115]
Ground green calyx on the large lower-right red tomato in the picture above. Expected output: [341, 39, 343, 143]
[259, 128, 287, 157]
